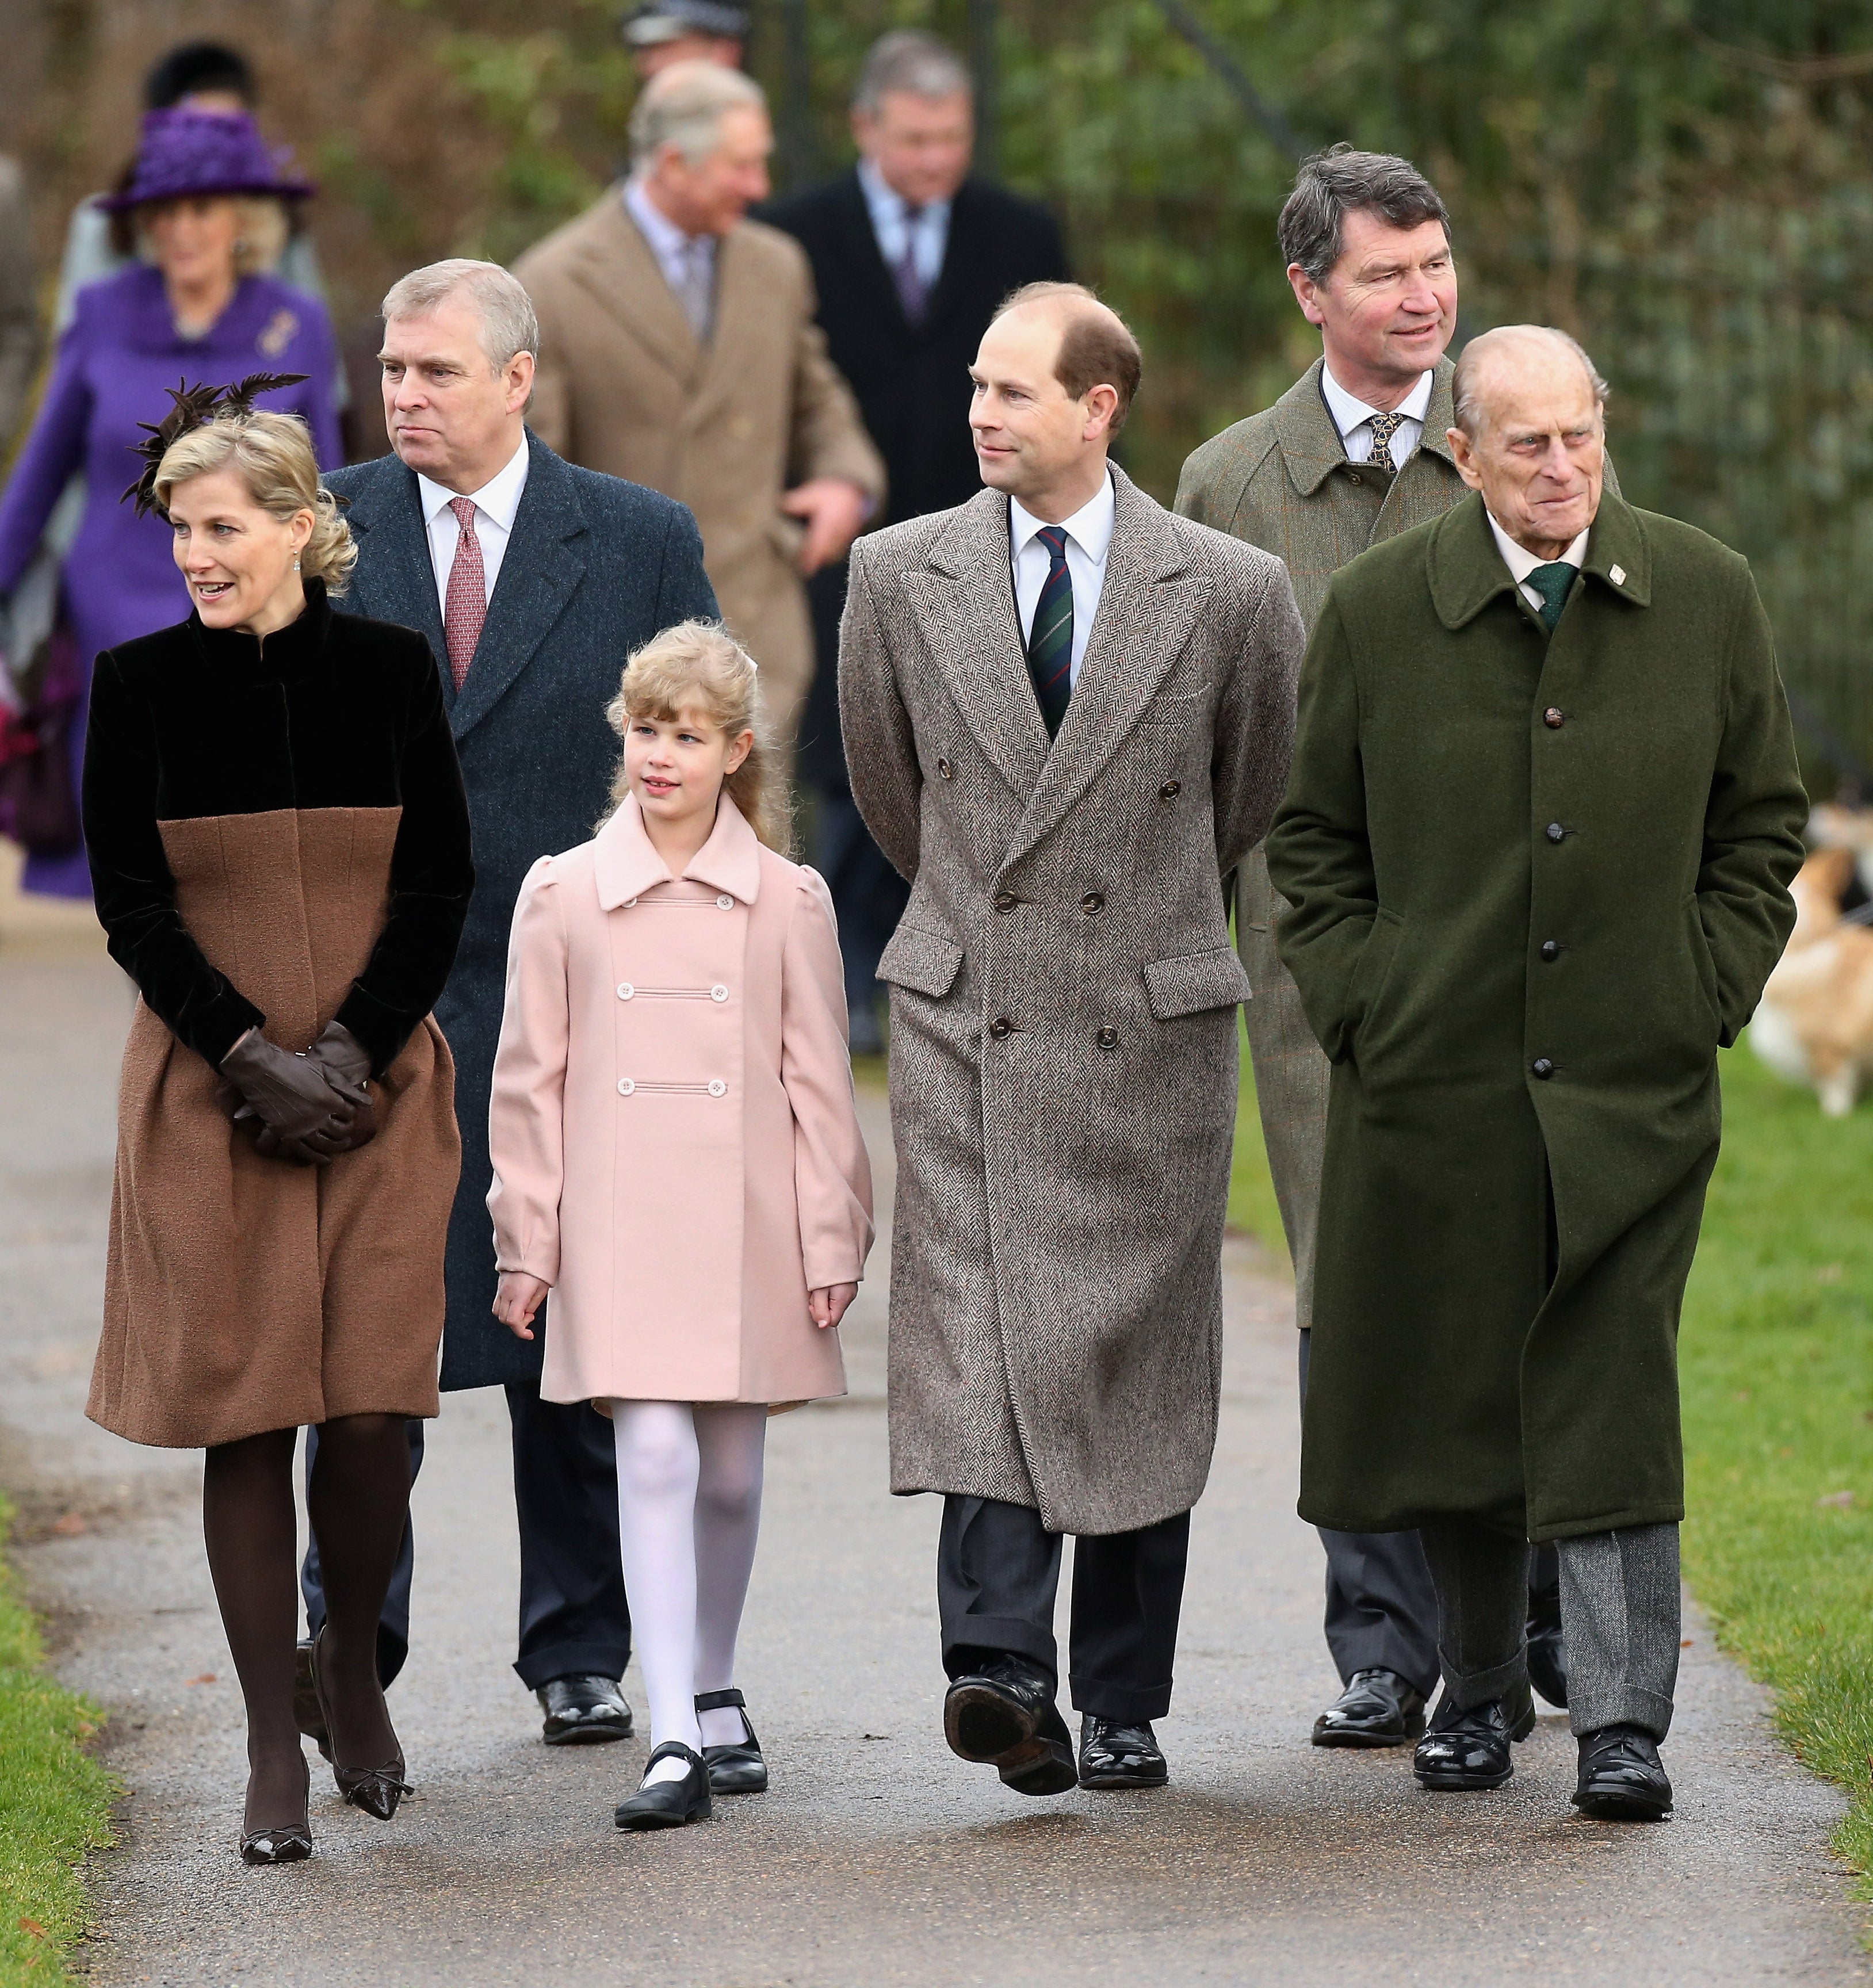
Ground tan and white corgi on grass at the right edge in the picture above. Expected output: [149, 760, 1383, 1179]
[1750, 845, 1873, 1117]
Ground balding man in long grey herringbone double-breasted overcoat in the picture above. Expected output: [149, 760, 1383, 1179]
[839, 284, 1302, 1795]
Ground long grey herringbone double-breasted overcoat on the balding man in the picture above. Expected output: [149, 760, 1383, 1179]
[839, 471, 1302, 1533]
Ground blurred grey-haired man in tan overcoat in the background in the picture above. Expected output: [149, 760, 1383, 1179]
[515, 62, 885, 741]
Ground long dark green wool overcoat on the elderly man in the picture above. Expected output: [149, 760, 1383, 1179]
[1267, 495, 1807, 1540]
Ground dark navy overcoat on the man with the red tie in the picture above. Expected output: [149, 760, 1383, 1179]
[326, 435, 716, 1387]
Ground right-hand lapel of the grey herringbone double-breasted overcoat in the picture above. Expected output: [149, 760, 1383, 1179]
[1002, 467, 1207, 863]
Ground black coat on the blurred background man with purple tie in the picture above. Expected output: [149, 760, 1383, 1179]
[762, 167, 1068, 785]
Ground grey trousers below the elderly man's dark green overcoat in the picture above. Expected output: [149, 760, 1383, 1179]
[1417, 1523, 1682, 1740]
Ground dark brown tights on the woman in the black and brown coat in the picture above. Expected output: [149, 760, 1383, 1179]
[201, 1416, 410, 1829]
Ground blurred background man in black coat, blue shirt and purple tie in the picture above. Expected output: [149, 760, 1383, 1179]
[763, 30, 1068, 1054]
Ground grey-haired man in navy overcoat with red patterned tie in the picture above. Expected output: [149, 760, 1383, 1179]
[306, 261, 716, 1744]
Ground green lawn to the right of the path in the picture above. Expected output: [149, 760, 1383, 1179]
[1229, 1043, 1873, 1898]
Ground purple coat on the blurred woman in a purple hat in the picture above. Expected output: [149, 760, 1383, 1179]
[0, 265, 344, 897]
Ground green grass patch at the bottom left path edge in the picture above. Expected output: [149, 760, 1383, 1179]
[0, 1499, 117, 1988]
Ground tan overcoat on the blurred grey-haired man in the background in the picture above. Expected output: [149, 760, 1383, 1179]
[515, 187, 885, 737]
